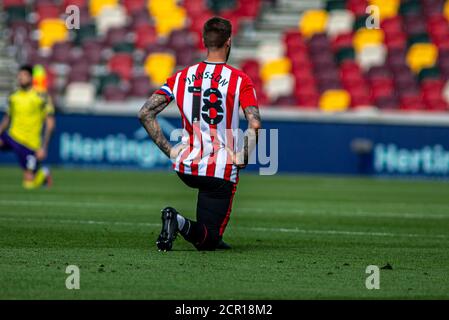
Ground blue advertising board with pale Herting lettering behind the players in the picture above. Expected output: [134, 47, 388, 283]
[0, 115, 449, 177]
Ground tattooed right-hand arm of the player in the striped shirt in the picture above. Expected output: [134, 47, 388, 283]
[234, 106, 262, 168]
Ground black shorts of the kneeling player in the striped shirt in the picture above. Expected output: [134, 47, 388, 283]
[176, 172, 237, 238]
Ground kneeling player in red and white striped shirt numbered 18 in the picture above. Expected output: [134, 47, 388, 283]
[139, 17, 261, 251]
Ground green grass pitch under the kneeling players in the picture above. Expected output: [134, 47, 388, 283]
[0, 167, 449, 299]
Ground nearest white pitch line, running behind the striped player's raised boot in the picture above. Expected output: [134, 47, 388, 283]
[0, 217, 449, 239]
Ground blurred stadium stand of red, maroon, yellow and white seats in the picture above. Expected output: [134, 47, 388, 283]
[0, 0, 449, 111]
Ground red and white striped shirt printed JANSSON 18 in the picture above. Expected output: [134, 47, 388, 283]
[156, 61, 258, 182]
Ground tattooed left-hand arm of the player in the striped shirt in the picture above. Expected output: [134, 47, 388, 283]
[139, 94, 172, 158]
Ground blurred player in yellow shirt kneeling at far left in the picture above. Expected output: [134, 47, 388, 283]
[0, 66, 55, 189]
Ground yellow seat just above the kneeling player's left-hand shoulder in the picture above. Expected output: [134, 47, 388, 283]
[144, 53, 176, 85]
